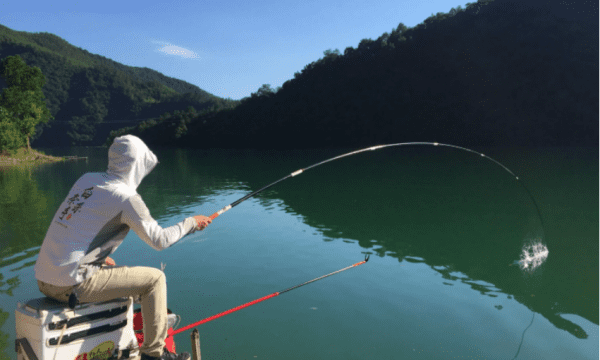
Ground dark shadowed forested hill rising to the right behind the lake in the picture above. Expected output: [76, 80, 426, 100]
[115, 0, 598, 148]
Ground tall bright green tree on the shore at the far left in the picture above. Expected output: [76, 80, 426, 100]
[0, 55, 53, 149]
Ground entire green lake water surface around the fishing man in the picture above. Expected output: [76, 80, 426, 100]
[0, 147, 599, 359]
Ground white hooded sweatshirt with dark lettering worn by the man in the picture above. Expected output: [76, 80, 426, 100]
[35, 135, 197, 286]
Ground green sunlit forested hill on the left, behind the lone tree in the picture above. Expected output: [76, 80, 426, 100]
[0, 25, 237, 147]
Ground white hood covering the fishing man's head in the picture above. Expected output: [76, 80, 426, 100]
[106, 135, 158, 189]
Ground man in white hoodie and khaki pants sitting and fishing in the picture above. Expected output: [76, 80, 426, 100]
[35, 135, 211, 360]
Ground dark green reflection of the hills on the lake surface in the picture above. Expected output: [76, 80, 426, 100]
[0, 148, 598, 339]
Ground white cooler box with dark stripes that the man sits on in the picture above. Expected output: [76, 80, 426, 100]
[15, 297, 139, 360]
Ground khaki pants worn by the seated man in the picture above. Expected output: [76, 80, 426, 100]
[38, 266, 168, 356]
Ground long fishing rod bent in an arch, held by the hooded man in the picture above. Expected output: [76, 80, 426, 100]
[209, 142, 544, 231]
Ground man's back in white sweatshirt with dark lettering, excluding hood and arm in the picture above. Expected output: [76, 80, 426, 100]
[35, 173, 136, 286]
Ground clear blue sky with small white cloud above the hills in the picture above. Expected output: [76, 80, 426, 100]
[0, 0, 476, 100]
